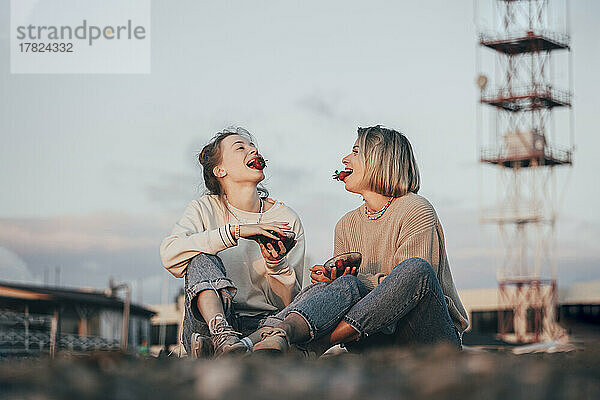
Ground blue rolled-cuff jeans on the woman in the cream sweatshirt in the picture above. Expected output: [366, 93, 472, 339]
[182, 253, 271, 354]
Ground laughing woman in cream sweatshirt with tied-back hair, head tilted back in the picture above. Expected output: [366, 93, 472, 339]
[160, 128, 304, 357]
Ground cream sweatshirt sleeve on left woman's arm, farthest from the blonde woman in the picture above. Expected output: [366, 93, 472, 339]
[160, 201, 237, 278]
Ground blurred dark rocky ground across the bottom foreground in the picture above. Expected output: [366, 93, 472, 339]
[0, 346, 600, 400]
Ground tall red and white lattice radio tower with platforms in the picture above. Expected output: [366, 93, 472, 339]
[475, 0, 573, 343]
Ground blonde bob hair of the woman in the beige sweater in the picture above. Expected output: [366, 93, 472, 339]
[358, 125, 421, 197]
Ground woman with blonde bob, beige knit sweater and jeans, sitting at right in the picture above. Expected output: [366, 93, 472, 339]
[254, 125, 468, 353]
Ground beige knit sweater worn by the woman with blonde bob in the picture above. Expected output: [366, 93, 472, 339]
[334, 193, 469, 334]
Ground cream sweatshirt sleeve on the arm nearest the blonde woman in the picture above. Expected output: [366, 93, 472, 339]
[266, 218, 306, 308]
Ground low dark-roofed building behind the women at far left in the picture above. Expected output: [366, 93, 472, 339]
[0, 282, 155, 355]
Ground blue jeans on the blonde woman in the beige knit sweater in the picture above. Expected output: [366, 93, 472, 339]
[265, 257, 461, 351]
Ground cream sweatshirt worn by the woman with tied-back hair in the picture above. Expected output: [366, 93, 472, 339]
[160, 195, 305, 315]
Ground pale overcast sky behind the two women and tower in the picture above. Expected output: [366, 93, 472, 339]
[0, 0, 600, 303]
